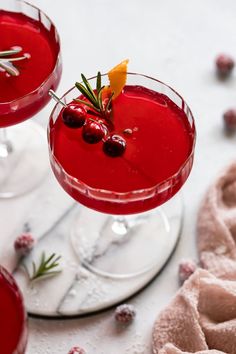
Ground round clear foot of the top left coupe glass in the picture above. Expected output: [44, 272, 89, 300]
[0, 121, 49, 198]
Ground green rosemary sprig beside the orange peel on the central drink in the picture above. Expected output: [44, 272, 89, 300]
[75, 72, 114, 119]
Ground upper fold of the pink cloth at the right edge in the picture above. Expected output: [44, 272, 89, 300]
[197, 163, 236, 281]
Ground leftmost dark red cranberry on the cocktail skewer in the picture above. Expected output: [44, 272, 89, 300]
[62, 103, 86, 128]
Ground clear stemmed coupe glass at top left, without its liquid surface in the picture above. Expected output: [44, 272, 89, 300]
[0, 0, 62, 198]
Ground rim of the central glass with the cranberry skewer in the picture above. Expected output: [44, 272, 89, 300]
[48, 72, 196, 202]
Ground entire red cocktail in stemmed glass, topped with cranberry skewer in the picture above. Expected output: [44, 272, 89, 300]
[48, 73, 195, 276]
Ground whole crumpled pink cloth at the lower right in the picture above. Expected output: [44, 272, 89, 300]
[153, 163, 236, 354]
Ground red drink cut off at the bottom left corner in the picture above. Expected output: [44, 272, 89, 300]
[0, 266, 27, 354]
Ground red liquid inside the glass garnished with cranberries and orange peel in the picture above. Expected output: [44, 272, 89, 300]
[50, 86, 194, 214]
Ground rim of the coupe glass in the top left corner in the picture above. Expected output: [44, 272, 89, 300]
[0, 0, 61, 107]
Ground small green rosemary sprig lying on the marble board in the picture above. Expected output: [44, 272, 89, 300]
[23, 252, 61, 281]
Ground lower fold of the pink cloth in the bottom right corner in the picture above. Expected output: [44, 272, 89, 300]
[153, 269, 236, 354]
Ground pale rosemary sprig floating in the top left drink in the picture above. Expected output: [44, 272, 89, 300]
[0, 47, 27, 76]
